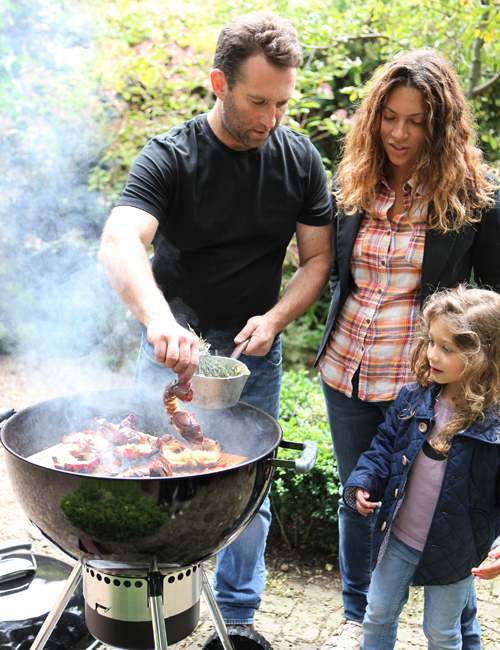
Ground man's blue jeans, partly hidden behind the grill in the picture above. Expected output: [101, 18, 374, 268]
[135, 332, 282, 625]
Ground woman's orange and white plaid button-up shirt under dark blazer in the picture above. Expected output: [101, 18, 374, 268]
[319, 179, 427, 402]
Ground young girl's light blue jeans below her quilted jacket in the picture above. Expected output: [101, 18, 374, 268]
[360, 533, 474, 650]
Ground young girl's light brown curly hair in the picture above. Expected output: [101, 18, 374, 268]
[411, 285, 500, 451]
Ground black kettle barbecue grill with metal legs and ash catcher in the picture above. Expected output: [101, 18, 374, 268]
[0, 389, 318, 650]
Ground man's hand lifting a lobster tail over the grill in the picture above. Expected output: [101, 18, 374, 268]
[148, 316, 199, 383]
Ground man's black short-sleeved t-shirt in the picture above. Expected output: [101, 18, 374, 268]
[117, 115, 331, 346]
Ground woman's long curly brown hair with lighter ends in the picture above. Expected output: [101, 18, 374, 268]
[334, 49, 496, 233]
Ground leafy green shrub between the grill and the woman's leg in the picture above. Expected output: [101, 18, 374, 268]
[271, 370, 340, 553]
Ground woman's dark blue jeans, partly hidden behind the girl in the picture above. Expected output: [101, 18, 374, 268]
[322, 373, 481, 650]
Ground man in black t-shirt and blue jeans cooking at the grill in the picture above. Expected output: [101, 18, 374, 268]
[99, 12, 331, 629]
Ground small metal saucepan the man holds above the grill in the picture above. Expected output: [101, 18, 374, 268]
[191, 357, 250, 409]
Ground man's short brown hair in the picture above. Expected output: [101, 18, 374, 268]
[214, 11, 303, 89]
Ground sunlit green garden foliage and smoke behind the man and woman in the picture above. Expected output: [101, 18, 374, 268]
[0, 0, 500, 360]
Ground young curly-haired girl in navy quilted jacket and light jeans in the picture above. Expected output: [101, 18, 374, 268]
[343, 286, 500, 650]
